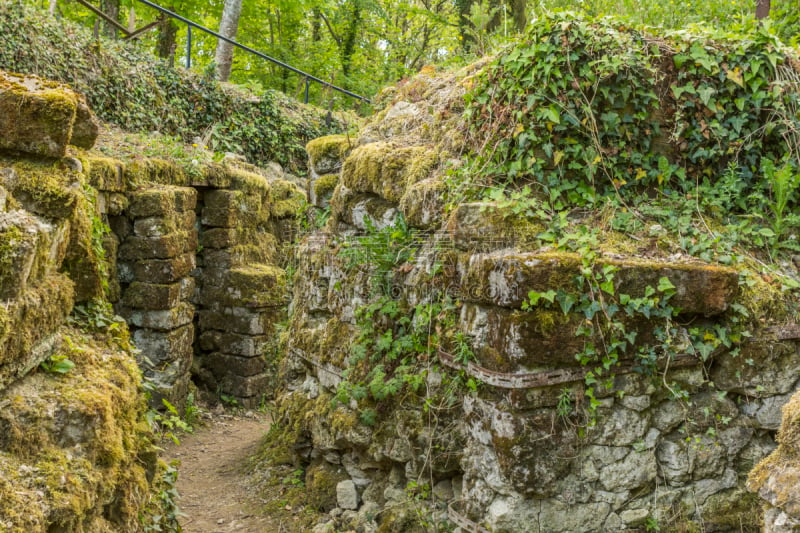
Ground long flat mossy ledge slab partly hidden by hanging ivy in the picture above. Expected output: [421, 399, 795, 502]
[462, 252, 739, 316]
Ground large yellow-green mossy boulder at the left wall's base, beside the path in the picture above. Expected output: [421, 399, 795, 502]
[0, 329, 158, 533]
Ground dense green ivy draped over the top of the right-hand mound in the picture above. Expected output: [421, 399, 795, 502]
[466, 13, 800, 211]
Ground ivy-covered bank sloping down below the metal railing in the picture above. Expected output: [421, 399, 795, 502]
[0, 1, 340, 172]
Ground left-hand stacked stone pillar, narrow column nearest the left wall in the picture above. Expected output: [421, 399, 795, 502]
[115, 187, 198, 407]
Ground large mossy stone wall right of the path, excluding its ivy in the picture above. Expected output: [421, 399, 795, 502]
[273, 98, 800, 533]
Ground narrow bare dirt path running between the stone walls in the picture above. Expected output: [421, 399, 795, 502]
[162, 413, 278, 533]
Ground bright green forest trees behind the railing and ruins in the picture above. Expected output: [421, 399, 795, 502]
[26, 0, 800, 108]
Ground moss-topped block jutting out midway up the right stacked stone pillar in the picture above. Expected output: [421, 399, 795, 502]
[200, 264, 288, 307]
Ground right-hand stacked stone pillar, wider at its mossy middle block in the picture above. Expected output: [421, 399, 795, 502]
[198, 185, 285, 407]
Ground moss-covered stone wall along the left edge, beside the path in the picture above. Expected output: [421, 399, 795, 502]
[0, 72, 164, 533]
